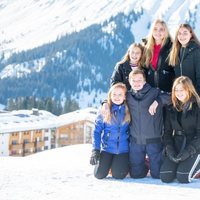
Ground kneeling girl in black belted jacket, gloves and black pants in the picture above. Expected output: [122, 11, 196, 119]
[160, 76, 200, 183]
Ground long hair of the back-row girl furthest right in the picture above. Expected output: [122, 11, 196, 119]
[169, 24, 200, 66]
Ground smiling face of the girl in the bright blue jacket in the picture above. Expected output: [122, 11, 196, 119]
[110, 87, 126, 105]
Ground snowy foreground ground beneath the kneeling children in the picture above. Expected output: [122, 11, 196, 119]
[0, 144, 200, 200]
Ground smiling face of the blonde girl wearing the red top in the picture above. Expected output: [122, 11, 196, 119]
[153, 22, 167, 45]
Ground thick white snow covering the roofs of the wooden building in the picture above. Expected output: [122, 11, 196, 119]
[0, 107, 98, 133]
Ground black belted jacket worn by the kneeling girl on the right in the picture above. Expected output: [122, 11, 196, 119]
[163, 103, 200, 152]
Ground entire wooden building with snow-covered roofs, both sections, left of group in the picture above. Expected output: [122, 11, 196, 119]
[0, 108, 97, 156]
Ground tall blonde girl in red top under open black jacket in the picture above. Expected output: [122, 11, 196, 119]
[144, 19, 175, 92]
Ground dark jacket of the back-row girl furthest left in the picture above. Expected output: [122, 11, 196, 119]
[110, 61, 135, 90]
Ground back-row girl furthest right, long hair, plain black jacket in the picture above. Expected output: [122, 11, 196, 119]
[169, 24, 200, 94]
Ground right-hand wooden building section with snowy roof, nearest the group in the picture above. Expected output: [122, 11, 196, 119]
[56, 108, 98, 147]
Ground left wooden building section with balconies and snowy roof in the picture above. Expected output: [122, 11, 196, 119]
[0, 110, 57, 156]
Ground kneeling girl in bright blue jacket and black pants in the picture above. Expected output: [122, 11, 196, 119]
[90, 83, 130, 179]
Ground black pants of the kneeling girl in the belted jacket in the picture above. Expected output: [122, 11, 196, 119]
[160, 153, 200, 183]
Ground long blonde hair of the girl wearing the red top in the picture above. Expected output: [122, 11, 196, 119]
[143, 19, 172, 67]
